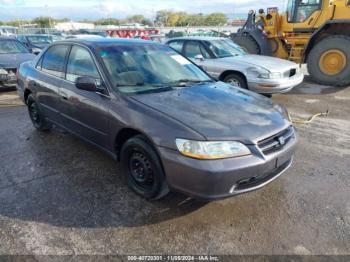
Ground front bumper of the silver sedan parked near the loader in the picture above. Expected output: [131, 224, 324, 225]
[248, 72, 304, 94]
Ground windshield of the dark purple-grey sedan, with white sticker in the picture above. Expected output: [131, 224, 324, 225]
[99, 44, 212, 93]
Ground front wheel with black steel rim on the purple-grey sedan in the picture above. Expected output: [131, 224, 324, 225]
[120, 135, 169, 200]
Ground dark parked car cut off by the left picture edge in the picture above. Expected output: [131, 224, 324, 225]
[0, 37, 35, 85]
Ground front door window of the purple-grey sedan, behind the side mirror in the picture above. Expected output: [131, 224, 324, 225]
[66, 46, 100, 82]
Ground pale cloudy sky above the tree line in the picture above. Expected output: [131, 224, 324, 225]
[0, 0, 287, 20]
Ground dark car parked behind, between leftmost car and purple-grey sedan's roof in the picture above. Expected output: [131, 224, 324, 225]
[17, 34, 53, 54]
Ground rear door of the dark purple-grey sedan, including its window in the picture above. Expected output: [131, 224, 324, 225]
[33, 44, 69, 124]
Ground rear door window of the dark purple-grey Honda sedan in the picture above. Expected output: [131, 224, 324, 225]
[42, 45, 68, 78]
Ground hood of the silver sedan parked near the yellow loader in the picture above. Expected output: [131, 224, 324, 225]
[220, 55, 298, 72]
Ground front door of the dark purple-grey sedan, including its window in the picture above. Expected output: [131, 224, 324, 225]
[60, 45, 110, 148]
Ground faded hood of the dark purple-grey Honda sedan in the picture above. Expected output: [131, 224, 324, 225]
[132, 82, 290, 144]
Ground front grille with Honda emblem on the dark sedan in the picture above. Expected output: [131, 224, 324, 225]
[258, 126, 294, 155]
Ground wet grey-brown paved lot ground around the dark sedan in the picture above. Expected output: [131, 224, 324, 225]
[0, 78, 350, 255]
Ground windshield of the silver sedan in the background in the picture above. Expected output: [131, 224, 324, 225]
[207, 39, 246, 58]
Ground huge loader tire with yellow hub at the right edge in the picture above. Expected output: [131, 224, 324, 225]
[307, 36, 350, 86]
